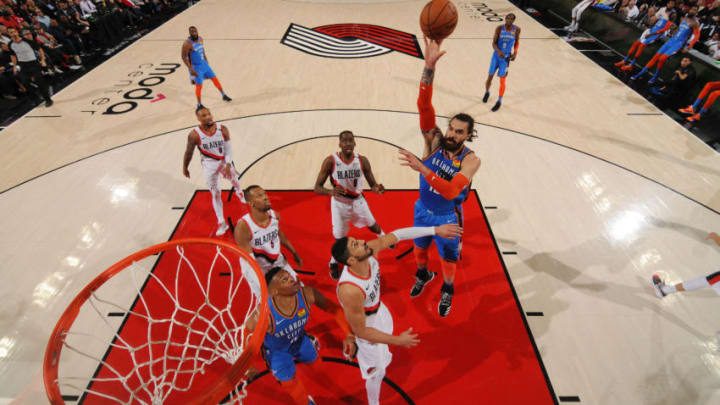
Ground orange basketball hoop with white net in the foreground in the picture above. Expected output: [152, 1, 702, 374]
[43, 238, 269, 405]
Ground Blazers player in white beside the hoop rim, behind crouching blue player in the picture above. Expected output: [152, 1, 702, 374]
[234, 185, 302, 289]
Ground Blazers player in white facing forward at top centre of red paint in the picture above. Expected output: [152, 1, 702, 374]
[315, 130, 385, 280]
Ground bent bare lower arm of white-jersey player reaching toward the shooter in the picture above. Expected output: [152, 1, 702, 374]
[338, 283, 420, 347]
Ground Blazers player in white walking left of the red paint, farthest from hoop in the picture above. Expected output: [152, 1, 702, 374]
[183, 107, 245, 236]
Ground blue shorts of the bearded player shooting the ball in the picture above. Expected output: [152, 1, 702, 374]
[413, 200, 463, 262]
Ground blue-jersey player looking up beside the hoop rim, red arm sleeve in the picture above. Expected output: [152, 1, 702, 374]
[247, 267, 357, 405]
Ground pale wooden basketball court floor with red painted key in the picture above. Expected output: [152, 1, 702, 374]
[0, 0, 720, 404]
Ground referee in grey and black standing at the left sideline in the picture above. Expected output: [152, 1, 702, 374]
[8, 28, 53, 107]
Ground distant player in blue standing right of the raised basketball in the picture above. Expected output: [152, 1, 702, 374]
[483, 13, 520, 111]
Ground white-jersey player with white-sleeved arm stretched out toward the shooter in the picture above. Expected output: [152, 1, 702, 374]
[332, 224, 462, 405]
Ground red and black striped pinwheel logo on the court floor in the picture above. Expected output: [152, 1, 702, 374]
[280, 23, 424, 59]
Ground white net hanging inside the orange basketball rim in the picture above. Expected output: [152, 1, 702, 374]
[52, 245, 260, 405]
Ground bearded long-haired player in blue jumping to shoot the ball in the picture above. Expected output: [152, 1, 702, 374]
[400, 39, 480, 317]
